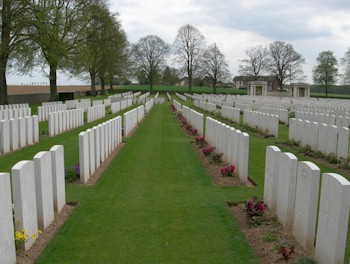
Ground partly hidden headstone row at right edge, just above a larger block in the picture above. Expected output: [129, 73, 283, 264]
[295, 111, 350, 127]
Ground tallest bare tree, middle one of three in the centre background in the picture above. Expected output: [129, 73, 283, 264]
[174, 24, 205, 91]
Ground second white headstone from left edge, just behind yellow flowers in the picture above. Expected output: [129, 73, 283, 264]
[11, 160, 38, 250]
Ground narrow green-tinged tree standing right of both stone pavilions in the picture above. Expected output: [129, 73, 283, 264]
[312, 50, 338, 97]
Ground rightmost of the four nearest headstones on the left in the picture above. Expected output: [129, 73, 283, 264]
[50, 145, 66, 213]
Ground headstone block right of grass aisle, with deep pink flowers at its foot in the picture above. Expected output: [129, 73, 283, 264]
[205, 117, 249, 182]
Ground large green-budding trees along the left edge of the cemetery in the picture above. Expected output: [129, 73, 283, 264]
[0, 0, 129, 104]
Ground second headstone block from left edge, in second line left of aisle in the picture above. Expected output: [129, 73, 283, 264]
[48, 109, 84, 137]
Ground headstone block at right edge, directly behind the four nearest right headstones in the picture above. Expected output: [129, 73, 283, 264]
[288, 118, 349, 159]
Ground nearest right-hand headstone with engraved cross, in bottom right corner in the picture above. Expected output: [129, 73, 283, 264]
[315, 173, 350, 264]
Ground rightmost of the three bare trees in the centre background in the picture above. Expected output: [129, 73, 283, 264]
[201, 43, 230, 93]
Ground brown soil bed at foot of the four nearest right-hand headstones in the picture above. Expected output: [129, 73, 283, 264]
[229, 204, 311, 264]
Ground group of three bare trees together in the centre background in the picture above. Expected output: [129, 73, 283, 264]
[131, 25, 230, 92]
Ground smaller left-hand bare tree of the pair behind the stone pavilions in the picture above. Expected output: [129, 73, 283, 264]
[239, 45, 269, 77]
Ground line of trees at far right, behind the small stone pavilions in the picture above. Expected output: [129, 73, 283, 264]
[239, 41, 350, 96]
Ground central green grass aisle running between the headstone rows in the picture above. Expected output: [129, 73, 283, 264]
[37, 102, 258, 263]
